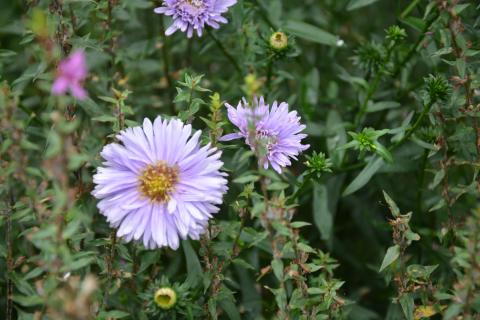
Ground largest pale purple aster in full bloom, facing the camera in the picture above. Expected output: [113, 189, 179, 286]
[92, 117, 231, 249]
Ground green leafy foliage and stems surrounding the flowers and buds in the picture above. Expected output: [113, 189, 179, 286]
[0, 0, 480, 319]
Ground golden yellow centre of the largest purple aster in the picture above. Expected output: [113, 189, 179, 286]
[139, 161, 178, 203]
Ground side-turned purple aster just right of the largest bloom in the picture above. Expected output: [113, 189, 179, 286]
[221, 97, 309, 173]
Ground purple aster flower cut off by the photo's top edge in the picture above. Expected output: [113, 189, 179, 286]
[154, 0, 237, 38]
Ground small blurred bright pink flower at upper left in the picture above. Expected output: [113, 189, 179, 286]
[52, 50, 88, 100]
